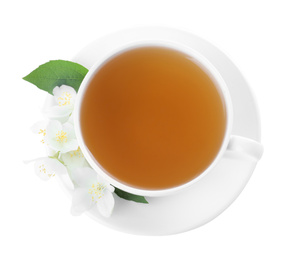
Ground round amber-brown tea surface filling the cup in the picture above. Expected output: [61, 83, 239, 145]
[80, 47, 226, 190]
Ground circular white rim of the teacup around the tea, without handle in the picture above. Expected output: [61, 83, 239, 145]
[73, 40, 233, 197]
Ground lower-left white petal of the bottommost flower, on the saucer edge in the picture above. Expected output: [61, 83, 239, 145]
[71, 187, 93, 216]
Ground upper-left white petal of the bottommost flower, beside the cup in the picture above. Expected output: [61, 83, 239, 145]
[71, 167, 97, 188]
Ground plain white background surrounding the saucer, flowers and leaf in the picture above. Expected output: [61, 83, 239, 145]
[0, 0, 295, 260]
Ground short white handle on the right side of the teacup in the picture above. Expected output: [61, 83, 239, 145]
[227, 135, 263, 161]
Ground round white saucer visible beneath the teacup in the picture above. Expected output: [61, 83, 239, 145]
[64, 28, 260, 235]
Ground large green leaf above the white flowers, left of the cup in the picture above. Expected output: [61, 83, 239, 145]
[23, 60, 88, 94]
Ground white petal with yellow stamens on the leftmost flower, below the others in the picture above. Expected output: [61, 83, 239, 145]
[35, 157, 67, 180]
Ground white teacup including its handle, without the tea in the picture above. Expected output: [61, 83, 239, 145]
[74, 41, 263, 197]
